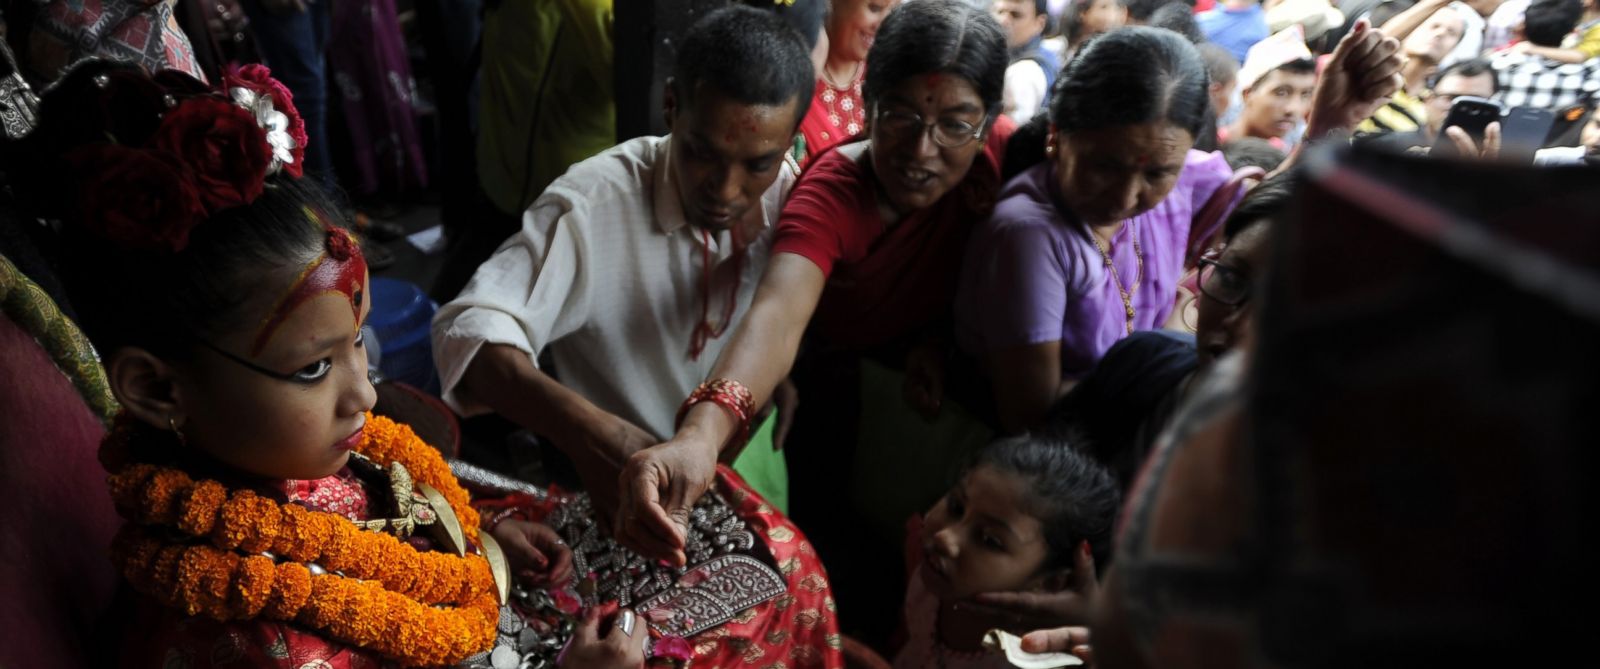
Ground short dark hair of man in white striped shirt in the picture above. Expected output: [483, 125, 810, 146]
[672, 5, 816, 126]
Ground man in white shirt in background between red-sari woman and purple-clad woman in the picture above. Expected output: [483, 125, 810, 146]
[994, 0, 1061, 125]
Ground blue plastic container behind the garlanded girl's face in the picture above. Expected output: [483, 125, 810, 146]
[366, 278, 438, 395]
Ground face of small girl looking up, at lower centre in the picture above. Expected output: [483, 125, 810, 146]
[922, 467, 1050, 602]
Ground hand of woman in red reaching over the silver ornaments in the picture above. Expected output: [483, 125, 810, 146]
[613, 432, 717, 567]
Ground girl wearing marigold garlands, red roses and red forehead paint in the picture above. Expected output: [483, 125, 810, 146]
[3, 62, 648, 667]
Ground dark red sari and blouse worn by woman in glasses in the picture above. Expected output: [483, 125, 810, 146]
[773, 117, 1016, 351]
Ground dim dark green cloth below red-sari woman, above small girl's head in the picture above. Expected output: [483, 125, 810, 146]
[850, 360, 994, 540]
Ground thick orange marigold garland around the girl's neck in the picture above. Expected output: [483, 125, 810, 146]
[101, 415, 499, 666]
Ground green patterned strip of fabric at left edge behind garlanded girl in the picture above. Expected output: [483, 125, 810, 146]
[0, 256, 118, 426]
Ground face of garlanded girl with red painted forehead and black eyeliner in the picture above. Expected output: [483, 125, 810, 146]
[174, 256, 378, 479]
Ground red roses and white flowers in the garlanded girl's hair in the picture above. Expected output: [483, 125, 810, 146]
[43, 62, 306, 253]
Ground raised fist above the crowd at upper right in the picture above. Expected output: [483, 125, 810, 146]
[1306, 19, 1405, 141]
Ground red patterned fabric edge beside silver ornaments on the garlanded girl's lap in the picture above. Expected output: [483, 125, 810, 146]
[690, 466, 845, 669]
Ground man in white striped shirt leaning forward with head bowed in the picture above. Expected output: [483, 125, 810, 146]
[434, 6, 814, 514]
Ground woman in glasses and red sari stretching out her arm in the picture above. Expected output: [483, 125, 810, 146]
[622, 0, 1014, 643]
